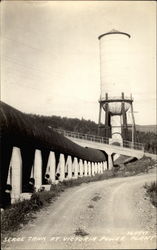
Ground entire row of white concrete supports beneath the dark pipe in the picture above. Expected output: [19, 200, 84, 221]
[7, 147, 107, 200]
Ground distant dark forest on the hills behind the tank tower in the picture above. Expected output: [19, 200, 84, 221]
[30, 114, 157, 153]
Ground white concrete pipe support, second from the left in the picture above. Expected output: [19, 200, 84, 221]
[34, 149, 42, 190]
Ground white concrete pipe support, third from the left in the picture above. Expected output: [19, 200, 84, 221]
[47, 151, 56, 183]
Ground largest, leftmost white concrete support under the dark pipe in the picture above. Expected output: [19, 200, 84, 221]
[9, 147, 22, 199]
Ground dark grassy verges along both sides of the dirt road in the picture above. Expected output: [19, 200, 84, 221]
[1, 157, 155, 238]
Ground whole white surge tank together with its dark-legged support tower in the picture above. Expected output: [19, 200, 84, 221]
[98, 30, 135, 145]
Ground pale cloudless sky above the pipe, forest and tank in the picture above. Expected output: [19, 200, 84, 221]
[1, 1, 156, 125]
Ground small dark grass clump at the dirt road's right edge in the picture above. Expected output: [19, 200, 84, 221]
[144, 181, 157, 207]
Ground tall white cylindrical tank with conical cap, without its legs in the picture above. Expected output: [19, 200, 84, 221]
[99, 30, 130, 114]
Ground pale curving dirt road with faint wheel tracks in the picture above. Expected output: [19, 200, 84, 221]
[2, 173, 156, 250]
